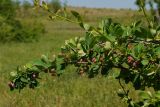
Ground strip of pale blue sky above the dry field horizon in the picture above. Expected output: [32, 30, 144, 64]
[25, 0, 137, 9]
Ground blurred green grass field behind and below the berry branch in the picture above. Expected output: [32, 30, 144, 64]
[0, 7, 141, 107]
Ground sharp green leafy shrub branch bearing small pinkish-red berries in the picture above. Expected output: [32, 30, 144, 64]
[8, 0, 160, 107]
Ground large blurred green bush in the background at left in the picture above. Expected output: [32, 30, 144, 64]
[0, 0, 45, 43]
